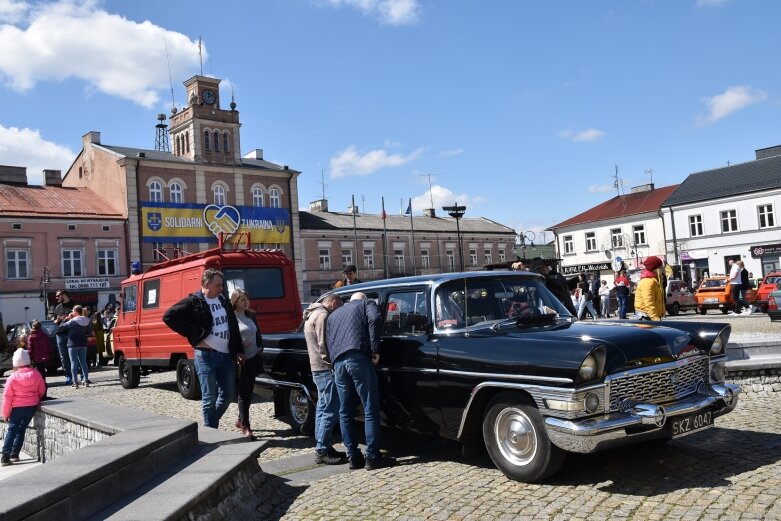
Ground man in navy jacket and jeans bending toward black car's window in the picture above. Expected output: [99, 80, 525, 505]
[325, 292, 396, 470]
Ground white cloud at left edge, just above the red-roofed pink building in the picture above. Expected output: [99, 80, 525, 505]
[0, 125, 76, 184]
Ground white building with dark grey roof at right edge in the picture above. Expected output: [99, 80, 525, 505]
[661, 146, 781, 281]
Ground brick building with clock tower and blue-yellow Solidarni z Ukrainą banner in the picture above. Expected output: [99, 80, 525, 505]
[63, 75, 301, 298]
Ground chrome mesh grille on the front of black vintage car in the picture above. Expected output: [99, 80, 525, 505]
[607, 357, 709, 411]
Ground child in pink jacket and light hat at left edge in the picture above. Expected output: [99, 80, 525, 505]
[0, 348, 46, 467]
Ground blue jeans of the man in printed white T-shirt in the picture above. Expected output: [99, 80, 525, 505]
[195, 349, 236, 429]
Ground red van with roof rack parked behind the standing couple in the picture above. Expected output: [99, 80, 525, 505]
[110, 239, 301, 400]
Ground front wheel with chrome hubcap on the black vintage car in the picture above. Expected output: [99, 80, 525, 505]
[483, 393, 565, 483]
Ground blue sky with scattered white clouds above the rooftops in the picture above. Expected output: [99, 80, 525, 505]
[0, 0, 781, 239]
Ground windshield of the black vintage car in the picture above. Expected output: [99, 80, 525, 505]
[434, 276, 570, 328]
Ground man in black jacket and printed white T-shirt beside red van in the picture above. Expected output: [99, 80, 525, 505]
[163, 268, 244, 429]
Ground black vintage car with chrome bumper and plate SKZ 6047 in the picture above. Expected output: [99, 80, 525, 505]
[257, 271, 740, 481]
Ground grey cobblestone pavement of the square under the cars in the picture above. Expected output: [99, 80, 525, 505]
[29, 366, 781, 521]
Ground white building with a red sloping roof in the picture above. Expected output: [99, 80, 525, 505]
[551, 184, 678, 282]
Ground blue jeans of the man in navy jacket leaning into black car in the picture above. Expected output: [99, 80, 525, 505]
[334, 349, 380, 458]
